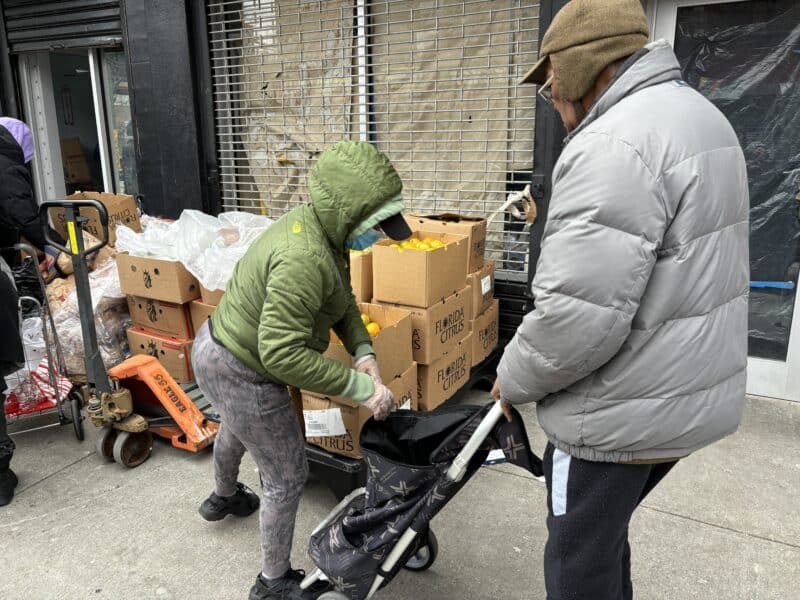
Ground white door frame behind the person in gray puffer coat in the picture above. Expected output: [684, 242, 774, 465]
[645, 0, 800, 402]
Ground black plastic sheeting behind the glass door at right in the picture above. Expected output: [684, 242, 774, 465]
[675, 0, 800, 360]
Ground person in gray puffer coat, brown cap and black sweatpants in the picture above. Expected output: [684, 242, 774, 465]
[493, 0, 749, 600]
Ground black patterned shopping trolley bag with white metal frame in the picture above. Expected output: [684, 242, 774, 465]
[302, 403, 544, 600]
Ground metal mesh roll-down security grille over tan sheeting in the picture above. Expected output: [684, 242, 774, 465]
[206, 0, 539, 279]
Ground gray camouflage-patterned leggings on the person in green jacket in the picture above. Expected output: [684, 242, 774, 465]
[192, 322, 308, 578]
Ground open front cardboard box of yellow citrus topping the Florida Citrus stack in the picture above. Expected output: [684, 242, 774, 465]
[372, 229, 468, 308]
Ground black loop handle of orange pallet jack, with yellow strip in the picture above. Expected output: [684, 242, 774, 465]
[39, 200, 112, 396]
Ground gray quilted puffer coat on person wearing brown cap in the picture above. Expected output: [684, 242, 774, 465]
[498, 41, 749, 462]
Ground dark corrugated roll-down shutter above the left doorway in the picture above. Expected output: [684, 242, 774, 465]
[3, 0, 122, 52]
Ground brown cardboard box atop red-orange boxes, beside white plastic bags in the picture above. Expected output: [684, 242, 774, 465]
[117, 253, 200, 304]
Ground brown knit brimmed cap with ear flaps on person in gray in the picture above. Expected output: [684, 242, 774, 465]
[520, 0, 650, 102]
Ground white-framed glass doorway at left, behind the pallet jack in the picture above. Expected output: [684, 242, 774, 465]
[20, 48, 138, 200]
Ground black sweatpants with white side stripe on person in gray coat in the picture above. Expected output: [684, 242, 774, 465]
[544, 444, 677, 600]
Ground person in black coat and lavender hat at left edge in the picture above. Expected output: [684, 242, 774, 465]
[0, 117, 63, 506]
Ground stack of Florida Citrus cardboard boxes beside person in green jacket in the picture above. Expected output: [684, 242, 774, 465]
[295, 215, 499, 458]
